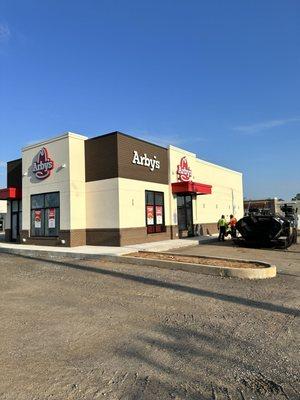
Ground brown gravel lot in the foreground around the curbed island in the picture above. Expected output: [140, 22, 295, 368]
[0, 243, 300, 400]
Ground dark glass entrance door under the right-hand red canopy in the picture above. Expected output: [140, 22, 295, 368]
[177, 194, 194, 236]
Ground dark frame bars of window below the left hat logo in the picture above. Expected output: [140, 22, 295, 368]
[30, 191, 60, 238]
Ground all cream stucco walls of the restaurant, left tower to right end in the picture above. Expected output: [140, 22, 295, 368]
[16, 132, 243, 241]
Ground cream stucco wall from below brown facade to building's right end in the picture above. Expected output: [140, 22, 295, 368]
[86, 146, 243, 229]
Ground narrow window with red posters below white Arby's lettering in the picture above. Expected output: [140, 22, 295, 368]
[146, 190, 166, 233]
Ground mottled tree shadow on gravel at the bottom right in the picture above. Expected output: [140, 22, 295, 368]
[115, 323, 290, 400]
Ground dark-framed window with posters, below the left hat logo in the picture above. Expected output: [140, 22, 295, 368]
[31, 192, 60, 236]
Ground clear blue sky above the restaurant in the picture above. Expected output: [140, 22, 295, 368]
[0, 0, 300, 199]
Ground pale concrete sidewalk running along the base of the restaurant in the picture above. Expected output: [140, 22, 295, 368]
[0, 236, 216, 258]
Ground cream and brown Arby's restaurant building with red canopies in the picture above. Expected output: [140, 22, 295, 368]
[0, 132, 243, 246]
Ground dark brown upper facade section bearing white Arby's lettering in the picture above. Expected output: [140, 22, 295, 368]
[85, 132, 168, 184]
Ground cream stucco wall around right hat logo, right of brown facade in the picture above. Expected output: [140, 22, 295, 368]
[169, 146, 244, 224]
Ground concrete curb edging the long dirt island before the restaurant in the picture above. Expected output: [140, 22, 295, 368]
[0, 244, 276, 279]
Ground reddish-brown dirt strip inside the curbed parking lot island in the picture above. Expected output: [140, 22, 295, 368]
[126, 251, 266, 268]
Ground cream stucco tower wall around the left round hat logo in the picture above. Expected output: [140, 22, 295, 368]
[22, 132, 86, 230]
